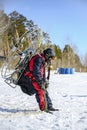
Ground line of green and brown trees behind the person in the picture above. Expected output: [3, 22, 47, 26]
[0, 10, 87, 71]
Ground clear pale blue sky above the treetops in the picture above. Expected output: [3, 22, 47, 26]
[0, 0, 87, 55]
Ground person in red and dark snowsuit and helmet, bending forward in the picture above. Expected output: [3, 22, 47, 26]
[18, 48, 55, 111]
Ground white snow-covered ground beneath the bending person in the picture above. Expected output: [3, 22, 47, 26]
[0, 72, 87, 130]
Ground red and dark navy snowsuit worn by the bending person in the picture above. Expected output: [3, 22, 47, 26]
[19, 54, 52, 110]
